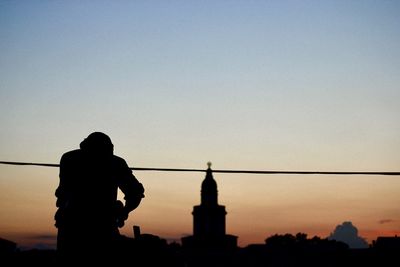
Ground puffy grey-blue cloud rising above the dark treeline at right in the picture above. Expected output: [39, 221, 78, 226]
[328, 222, 368, 248]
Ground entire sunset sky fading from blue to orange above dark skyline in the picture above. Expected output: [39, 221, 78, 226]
[0, 0, 400, 250]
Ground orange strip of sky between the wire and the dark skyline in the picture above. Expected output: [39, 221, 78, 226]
[0, 166, 400, 250]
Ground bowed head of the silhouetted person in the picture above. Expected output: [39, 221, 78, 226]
[80, 132, 114, 155]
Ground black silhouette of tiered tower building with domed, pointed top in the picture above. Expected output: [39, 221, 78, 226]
[182, 162, 237, 249]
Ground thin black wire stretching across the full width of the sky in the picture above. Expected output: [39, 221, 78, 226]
[0, 161, 400, 176]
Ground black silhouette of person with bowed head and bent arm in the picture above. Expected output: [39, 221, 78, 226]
[55, 132, 144, 259]
